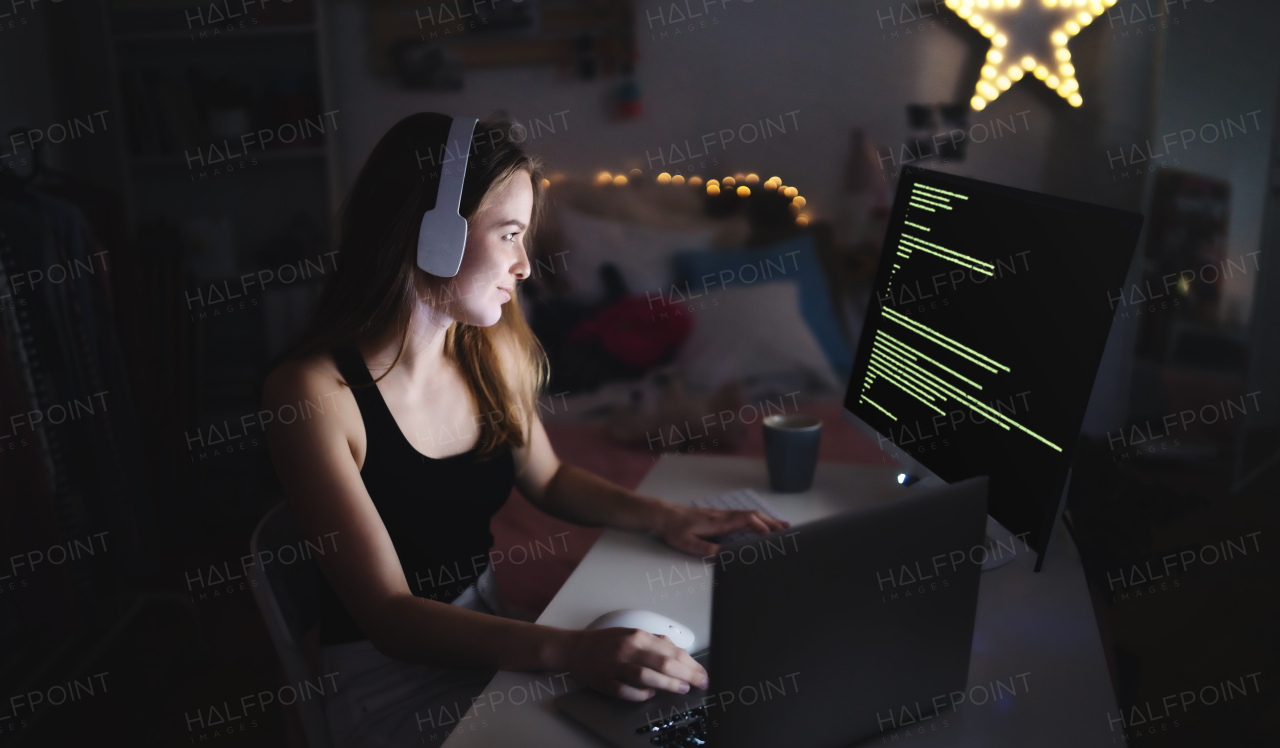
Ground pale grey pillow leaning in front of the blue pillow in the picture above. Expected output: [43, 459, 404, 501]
[675, 281, 845, 394]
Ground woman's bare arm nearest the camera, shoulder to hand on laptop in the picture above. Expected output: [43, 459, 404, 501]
[262, 365, 707, 701]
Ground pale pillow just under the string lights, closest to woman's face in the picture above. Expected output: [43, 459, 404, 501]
[557, 209, 714, 304]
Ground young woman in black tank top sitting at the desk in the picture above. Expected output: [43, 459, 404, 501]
[262, 113, 785, 745]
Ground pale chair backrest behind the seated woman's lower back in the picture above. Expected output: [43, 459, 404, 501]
[248, 501, 333, 748]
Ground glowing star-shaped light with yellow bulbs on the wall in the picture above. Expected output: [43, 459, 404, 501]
[946, 0, 1116, 109]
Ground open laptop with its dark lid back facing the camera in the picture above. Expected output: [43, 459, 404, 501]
[556, 476, 987, 748]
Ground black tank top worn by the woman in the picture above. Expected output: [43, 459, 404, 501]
[317, 348, 516, 644]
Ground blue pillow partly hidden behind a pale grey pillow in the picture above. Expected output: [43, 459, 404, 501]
[671, 233, 854, 378]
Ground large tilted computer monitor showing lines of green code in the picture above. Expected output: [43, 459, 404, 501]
[845, 168, 1143, 571]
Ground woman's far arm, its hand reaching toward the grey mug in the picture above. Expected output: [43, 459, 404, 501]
[516, 419, 790, 556]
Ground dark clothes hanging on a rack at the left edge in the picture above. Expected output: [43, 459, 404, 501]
[0, 175, 154, 643]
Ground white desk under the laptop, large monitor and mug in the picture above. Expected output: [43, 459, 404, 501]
[444, 456, 1123, 748]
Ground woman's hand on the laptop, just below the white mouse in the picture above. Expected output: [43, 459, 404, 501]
[564, 628, 707, 701]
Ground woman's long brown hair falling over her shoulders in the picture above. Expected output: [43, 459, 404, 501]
[285, 111, 548, 456]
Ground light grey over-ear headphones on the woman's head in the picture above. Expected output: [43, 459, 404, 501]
[417, 117, 479, 278]
